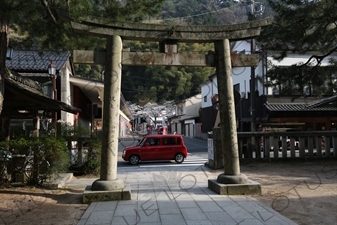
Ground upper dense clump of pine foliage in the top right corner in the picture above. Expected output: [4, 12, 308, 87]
[259, 0, 337, 54]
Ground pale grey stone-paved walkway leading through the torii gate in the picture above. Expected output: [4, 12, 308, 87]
[65, 163, 296, 225]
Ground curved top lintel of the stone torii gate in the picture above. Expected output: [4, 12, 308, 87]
[71, 18, 272, 43]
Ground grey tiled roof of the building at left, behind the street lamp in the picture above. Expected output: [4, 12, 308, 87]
[6, 49, 70, 72]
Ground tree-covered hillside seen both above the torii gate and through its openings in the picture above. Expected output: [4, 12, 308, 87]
[122, 0, 271, 105]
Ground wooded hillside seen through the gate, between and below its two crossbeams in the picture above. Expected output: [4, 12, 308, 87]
[122, 42, 215, 105]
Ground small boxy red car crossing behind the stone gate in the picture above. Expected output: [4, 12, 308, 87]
[122, 134, 187, 165]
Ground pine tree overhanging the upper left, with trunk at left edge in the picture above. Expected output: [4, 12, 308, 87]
[0, 0, 165, 113]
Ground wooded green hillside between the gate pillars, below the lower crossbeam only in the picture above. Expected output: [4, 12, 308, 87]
[122, 66, 210, 105]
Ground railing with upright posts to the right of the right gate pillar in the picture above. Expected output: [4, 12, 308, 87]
[238, 131, 337, 159]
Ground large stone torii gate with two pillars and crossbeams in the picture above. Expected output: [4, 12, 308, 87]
[64, 13, 272, 201]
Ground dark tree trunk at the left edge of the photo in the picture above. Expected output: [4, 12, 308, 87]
[0, 15, 9, 114]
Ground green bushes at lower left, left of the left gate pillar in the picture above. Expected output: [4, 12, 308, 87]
[0, 120, 101, 184]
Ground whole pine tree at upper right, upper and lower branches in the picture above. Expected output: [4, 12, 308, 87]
[258, 0, 337, 95]
